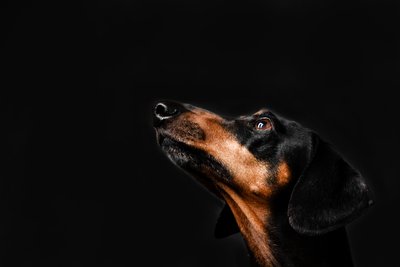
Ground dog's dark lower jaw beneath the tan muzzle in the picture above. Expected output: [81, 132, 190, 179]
[157, 131, 231, 187]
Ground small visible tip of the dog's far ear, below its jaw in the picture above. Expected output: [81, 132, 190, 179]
[214, 204, 239, 238]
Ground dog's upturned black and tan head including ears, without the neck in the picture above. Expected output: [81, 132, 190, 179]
[154, 102, 372, 237]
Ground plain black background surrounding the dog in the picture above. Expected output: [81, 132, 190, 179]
[0, 0, 400, 267]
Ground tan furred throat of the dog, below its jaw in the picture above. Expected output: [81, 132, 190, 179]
[220, 186, 280, 267]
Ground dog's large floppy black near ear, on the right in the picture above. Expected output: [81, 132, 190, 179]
[288, 133, 373, 235]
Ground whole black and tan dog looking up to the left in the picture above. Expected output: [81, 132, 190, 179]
[153, 101, 373, 266]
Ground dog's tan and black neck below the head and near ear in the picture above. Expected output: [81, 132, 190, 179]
[221, 187, 353, 267]
